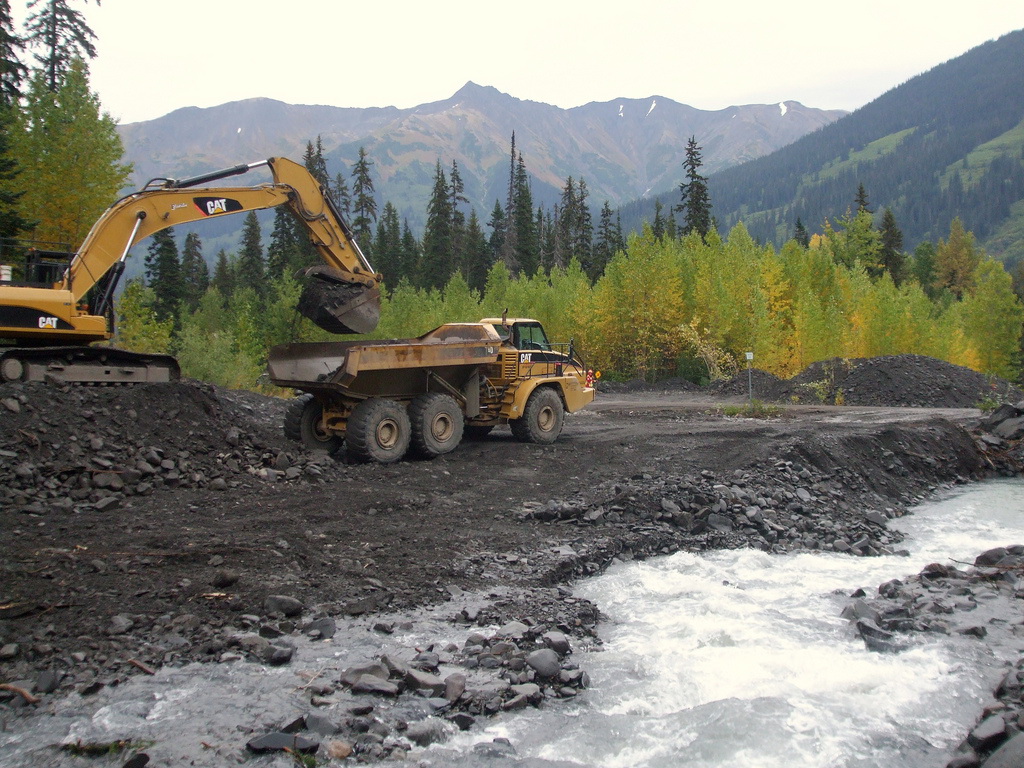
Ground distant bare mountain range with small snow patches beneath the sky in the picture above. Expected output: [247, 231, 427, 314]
[119, 83, 846, 231]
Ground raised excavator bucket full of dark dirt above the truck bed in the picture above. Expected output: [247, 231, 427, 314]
[297, 266, 381, 334]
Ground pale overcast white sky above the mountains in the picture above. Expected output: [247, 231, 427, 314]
[11, 0, 1024, 123]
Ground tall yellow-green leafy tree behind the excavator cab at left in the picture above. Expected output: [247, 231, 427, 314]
[10, 59, 131, 245]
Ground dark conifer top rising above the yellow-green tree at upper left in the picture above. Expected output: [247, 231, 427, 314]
[25, 0, 99, 93]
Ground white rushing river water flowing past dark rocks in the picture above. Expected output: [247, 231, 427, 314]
[0, 480, 1024, 768]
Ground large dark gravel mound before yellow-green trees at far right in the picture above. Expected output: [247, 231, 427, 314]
[790, 354, 1024, 408]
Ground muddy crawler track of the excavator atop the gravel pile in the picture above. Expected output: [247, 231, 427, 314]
[0, 346, 181, 384]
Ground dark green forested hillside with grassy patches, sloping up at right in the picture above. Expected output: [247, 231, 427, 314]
[698, 30, 1024, 268]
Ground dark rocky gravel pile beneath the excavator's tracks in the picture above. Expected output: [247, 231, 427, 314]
[0, 381, 333, 514]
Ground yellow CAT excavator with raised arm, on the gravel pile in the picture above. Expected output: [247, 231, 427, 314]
[0, 158, 381, 383]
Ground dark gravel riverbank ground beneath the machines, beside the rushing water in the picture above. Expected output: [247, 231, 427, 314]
[0, 370, 1020, 760]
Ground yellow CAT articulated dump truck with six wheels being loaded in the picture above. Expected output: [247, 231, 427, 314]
[267, 317, 594, 463]
